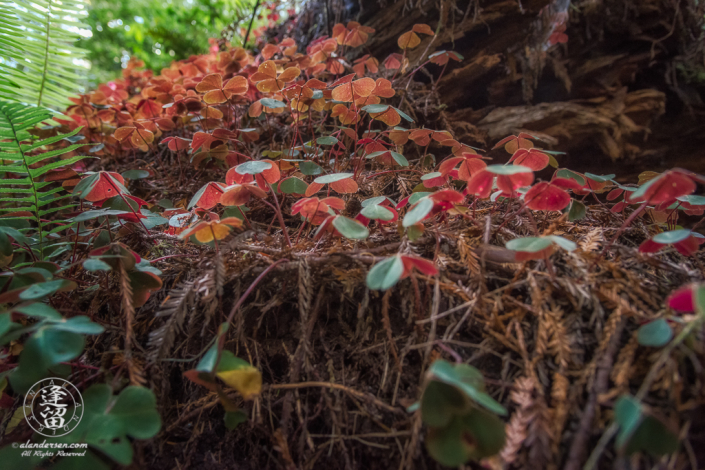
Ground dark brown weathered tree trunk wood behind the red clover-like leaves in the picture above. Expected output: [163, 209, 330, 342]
[288, 0, 705, 178]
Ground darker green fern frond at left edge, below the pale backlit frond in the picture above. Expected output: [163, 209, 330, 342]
[0, 100, 88, 258]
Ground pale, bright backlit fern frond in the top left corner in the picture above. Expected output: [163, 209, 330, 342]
[0, 0, 88, 109]
